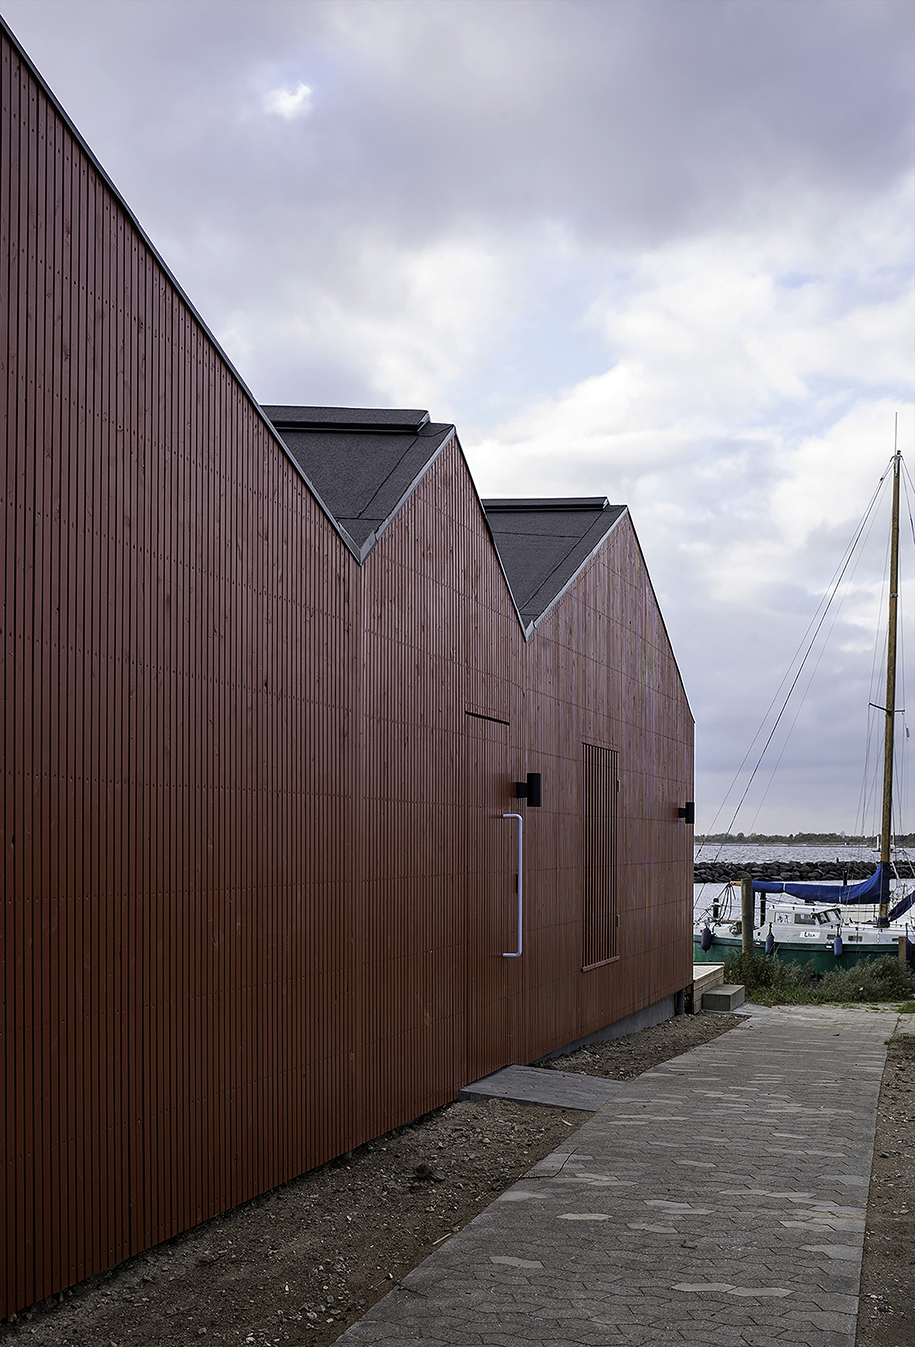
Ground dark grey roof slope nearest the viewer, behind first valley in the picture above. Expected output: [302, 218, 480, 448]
[261, 405, 454, 562]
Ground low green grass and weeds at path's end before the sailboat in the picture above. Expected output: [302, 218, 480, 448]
[725, 954, 915, 1012]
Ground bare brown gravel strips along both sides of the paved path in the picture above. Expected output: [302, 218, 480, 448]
[0, 1013, 915, 1347]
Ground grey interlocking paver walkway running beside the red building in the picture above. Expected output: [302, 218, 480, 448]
[340, 1006, 896, 1347]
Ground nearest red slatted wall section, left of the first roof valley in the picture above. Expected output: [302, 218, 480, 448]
[0, 35, 354, 1313]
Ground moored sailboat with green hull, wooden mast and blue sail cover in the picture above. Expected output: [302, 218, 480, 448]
[693, 449, 915, 973]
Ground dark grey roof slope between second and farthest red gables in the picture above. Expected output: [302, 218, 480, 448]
[482, 496, 625, 634]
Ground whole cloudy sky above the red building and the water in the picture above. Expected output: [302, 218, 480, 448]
[7, 0, 915, 832]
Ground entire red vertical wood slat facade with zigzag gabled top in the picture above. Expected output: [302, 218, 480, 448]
[0, 21, 693, 1315]
